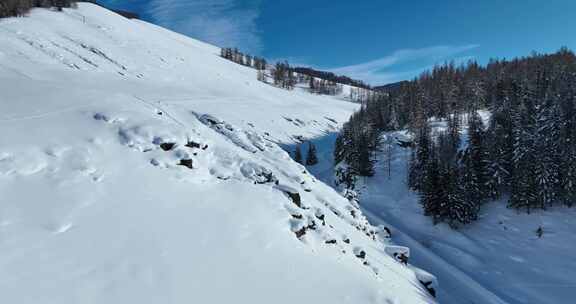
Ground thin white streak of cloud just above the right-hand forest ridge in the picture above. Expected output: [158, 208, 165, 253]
[330, 44, 479, 85]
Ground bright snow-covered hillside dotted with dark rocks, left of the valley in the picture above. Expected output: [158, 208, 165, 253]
[0, 4, 434, 304]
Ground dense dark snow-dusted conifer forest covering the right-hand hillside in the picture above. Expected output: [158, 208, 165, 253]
[335, 48, 576, 227]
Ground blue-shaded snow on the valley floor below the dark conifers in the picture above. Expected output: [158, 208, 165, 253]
[311, 117, 576, 304]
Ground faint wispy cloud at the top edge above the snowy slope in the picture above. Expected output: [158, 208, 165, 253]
[147, 0, 262, 53]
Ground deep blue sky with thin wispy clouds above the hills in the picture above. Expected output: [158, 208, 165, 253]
[102, 0, 576, 84]
